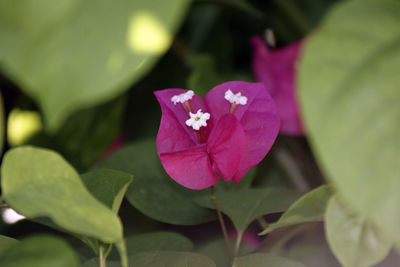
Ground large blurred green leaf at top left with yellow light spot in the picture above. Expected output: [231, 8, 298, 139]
[0, 0, 190, 130]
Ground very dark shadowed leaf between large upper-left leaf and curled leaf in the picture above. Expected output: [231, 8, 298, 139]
[26, 91, 127, 170]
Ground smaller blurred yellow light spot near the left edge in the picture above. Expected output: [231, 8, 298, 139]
[7, 109, 43, 146]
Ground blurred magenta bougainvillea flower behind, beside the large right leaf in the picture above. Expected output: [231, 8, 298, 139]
[251, 36, 304, 135]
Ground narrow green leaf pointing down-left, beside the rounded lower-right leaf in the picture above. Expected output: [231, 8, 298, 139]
[260, 185, 332, 235]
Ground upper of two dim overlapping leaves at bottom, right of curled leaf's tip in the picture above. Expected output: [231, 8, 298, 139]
[109, 231, 193, 259]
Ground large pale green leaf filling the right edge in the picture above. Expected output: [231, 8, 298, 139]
[299, 0, 400, 243]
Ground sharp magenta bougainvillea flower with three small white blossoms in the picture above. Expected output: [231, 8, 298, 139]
[154, 82, 279, 189]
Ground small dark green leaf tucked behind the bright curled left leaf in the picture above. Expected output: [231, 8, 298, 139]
[81, 169, 133, 214]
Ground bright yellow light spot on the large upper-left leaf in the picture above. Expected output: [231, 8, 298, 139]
[127, 11, 172, 54]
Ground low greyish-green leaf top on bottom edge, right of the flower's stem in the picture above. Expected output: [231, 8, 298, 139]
[232, 253, 306, 267]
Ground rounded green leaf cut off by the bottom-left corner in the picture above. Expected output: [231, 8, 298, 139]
[0, 235, 79, 267]
